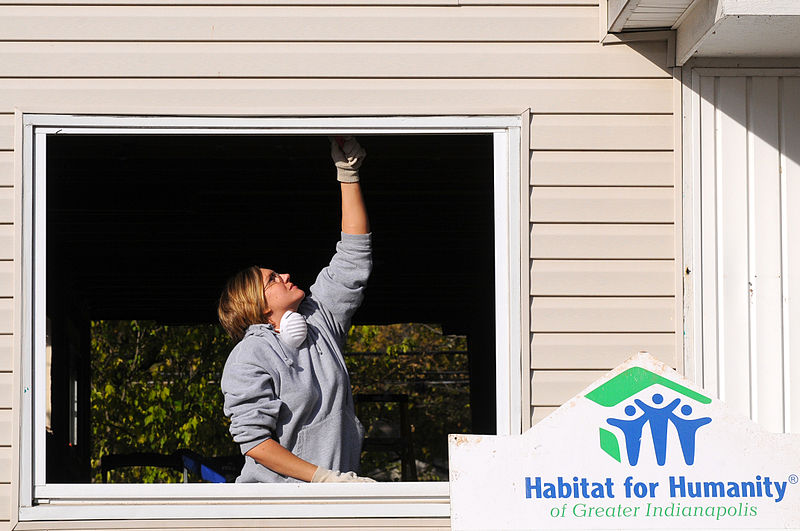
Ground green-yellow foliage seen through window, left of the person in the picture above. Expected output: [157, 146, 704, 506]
[91, 321, 238, 483]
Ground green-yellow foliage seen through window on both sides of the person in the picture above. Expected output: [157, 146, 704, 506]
[91, 321, 470, 483]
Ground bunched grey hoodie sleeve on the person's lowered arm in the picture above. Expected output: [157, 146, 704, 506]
[222, 363, 282, 454]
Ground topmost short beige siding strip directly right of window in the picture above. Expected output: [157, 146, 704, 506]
[531, 115, 674, 150]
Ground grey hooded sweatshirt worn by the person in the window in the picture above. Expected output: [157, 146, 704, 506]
[222, 233, 372, 483]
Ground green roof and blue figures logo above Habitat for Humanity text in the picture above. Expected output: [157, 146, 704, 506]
[586, 367, 711, 466]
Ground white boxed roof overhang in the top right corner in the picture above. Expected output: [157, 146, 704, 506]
[676, 0, 800, 65]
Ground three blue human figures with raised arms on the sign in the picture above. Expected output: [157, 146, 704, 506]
[606, 393, 711, 466]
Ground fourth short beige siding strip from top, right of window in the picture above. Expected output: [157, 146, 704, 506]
[531, 223, 675, 259]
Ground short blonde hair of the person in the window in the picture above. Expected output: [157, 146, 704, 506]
[217, 266, 268, 341]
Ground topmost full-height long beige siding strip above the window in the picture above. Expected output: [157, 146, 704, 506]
[0, 6, 599, 42]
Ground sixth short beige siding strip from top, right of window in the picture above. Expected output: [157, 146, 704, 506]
[531, 297, 675, 332]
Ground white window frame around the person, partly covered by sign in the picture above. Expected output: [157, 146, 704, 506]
[19, 114, 528, 521]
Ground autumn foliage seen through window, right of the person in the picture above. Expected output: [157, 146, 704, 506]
[346, 323, 471, 481]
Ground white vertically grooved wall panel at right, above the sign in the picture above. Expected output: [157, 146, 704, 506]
[683, 68, 800, 432]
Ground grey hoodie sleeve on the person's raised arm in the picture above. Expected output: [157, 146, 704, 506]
[310, 232, 372, 334]
